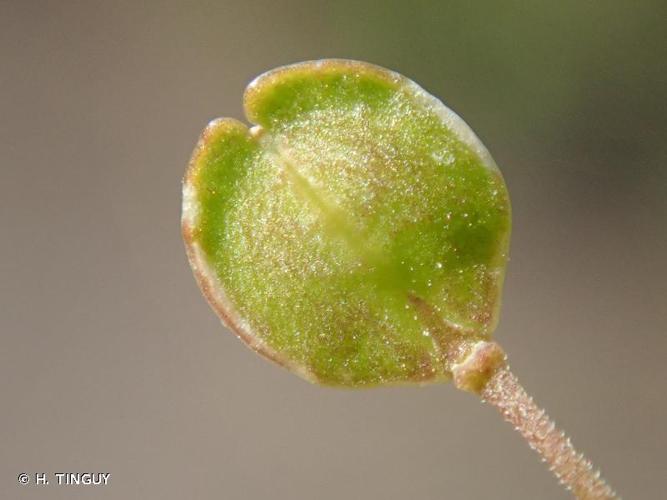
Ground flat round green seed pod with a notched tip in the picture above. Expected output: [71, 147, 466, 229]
[182, 60, 511, 387]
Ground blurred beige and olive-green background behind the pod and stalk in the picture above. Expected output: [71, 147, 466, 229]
[0, 0, 667, 500]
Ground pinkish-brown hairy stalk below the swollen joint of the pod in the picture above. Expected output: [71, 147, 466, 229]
[480, 365, 619, 500]
